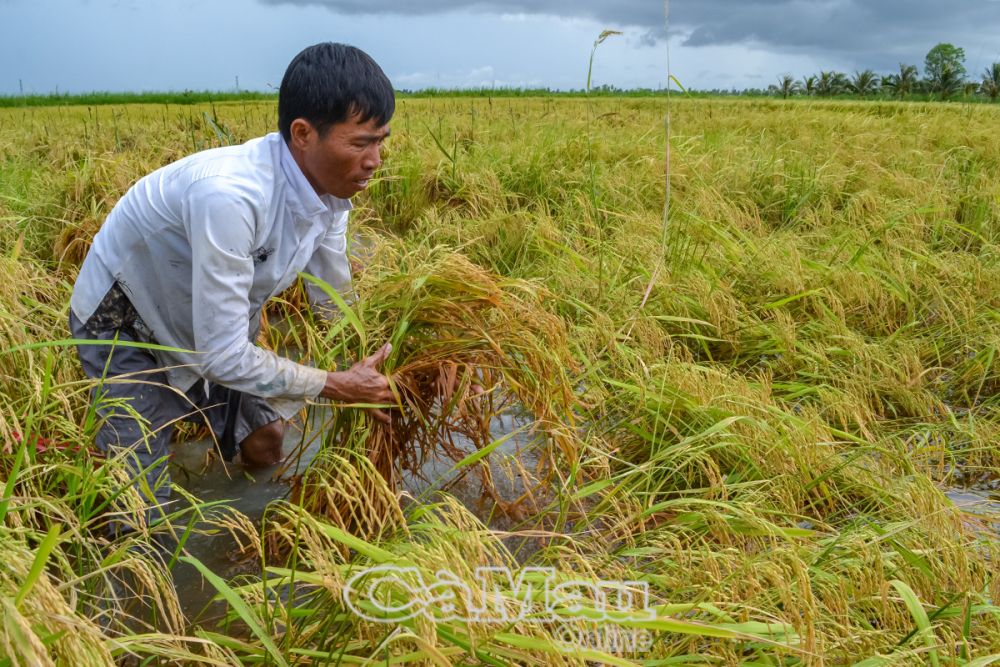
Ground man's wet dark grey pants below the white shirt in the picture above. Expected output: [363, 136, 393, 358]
[69, 284, 281, 520]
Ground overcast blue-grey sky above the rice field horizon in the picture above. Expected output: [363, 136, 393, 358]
[0, 0, 1000, 94]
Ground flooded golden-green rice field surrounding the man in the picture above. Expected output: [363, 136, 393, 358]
[0, 96, 1000, 667]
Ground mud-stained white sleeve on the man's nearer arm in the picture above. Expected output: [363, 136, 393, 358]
[183, 176, 326, 398]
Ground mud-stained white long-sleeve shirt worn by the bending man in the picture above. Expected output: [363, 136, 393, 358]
[70, 133, 351, 399]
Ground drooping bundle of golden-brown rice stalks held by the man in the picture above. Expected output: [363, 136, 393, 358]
[298, 244, 578, 536]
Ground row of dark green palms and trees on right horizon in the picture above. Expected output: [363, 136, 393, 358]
[767, 42, 1000, 102]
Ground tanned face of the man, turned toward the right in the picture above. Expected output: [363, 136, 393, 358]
[289, 114, 389, 199]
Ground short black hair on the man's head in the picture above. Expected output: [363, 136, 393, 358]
[278, 42, 396, 142]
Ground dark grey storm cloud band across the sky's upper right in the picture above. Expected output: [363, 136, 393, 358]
[262, 0, 1000, 67]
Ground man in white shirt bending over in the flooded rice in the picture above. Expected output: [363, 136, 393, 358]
[70, 43, 395, 518]
